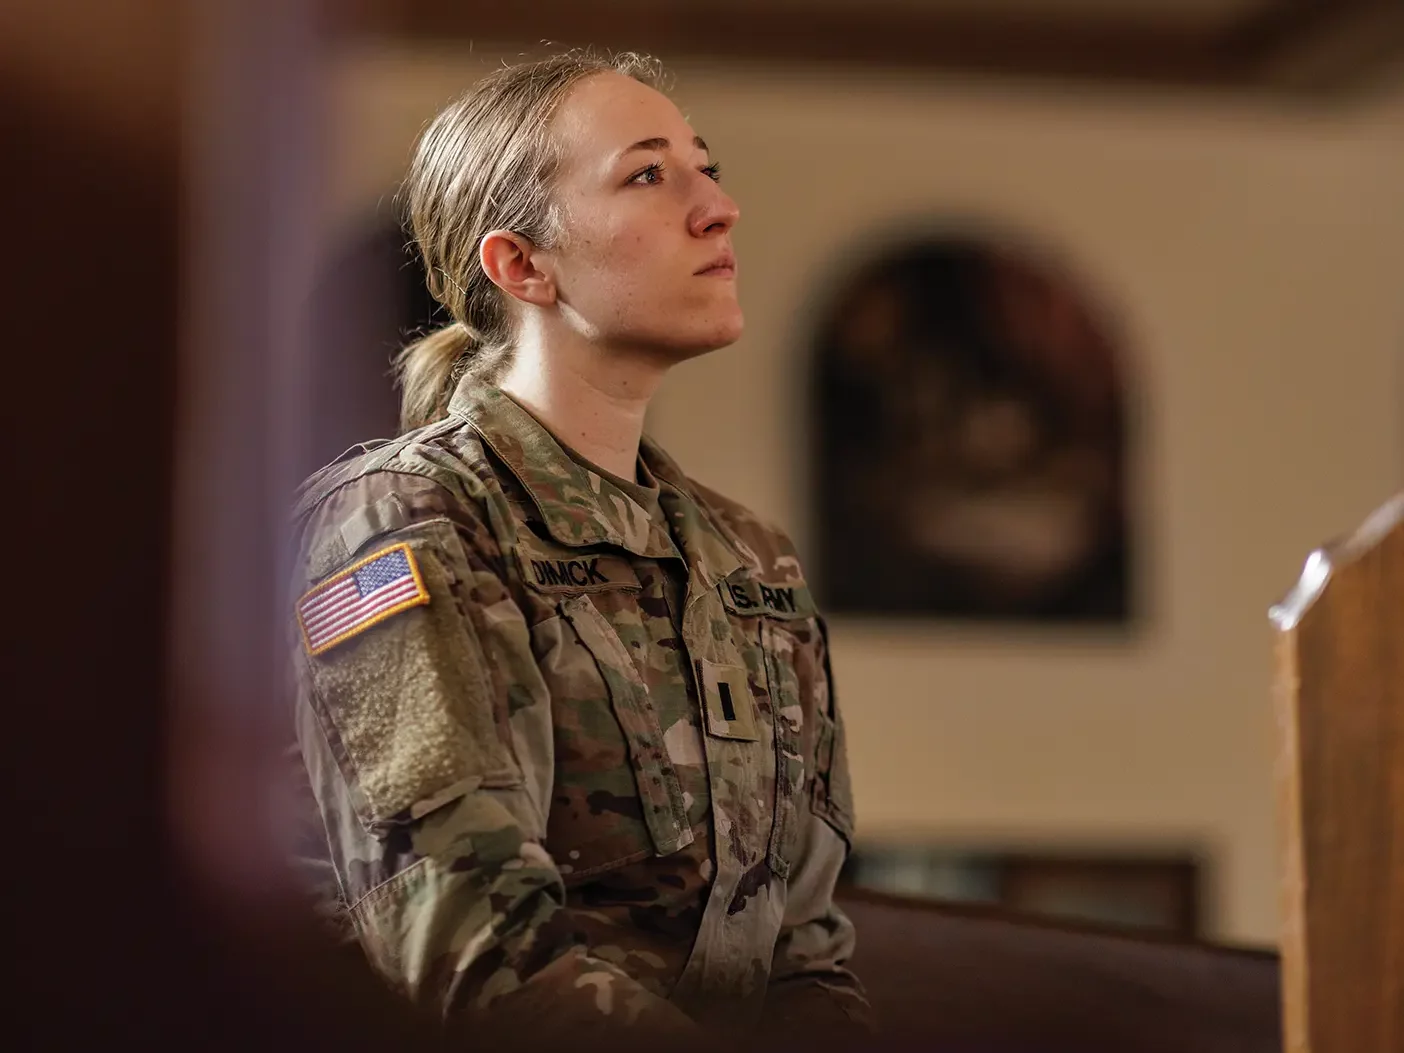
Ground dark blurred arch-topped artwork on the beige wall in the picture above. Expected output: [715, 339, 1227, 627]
[812, 236, 1134, 625]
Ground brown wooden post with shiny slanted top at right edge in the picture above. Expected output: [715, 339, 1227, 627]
[1271, 493, 1404, 1053]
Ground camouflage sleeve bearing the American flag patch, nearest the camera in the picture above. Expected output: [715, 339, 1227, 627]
[295, 486, 694, 1039]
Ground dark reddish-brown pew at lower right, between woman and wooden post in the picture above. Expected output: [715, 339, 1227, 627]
[840, 889, 1282, 1053]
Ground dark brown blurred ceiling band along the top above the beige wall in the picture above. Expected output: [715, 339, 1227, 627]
[348, 0, 1404, 97]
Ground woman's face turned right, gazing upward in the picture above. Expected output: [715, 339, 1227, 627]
[549, 73, 743, 361]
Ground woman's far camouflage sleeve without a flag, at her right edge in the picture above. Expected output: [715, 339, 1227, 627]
[762, 618, 873, 1042]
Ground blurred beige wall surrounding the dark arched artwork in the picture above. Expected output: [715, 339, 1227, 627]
[327, 43, 1404, 941]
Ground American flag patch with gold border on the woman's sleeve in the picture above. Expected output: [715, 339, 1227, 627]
[298, 542, 430, 654]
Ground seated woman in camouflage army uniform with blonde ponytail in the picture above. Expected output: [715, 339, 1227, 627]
[296, 53, 868, 1050]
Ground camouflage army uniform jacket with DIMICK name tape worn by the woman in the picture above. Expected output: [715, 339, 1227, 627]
[296, 382, 868, 1032]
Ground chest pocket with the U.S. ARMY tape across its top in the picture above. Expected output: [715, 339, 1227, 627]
[717, 571, 819, 879]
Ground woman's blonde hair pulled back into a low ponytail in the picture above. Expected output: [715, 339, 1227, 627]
[395, 51, 664, 431]
